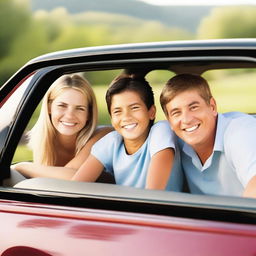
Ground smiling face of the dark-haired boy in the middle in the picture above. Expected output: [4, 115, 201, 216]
[110, 91, 155, 149]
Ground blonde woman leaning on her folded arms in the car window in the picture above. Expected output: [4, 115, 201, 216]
[12, 74, 112, 179]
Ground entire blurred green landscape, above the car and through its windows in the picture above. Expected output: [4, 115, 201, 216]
[6, 0, 256, 162]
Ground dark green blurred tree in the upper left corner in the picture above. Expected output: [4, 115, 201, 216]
[0, 0, 53, 86]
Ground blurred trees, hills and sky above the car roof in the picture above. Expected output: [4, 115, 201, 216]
[0, 0, 256, 85]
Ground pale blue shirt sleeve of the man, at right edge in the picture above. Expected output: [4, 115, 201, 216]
[224, 115, 256, 187]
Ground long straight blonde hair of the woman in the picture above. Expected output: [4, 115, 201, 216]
[28, 74, 98, 166]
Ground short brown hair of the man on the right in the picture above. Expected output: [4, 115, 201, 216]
[160, 74, 212, 114]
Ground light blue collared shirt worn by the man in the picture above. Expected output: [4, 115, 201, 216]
[179, 112, 256, 196]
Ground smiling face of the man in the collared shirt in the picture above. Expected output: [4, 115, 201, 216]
[166, 90, 217, 151]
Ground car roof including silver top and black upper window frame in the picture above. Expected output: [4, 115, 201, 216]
[0, 38, 256, 101]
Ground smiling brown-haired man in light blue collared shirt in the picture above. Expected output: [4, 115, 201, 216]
[160, 74, 256, 197]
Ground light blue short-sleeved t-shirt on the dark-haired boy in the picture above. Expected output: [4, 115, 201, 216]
[91, 121, 183, 191]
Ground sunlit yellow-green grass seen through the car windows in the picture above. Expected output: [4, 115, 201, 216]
[13, 73, 256, 162]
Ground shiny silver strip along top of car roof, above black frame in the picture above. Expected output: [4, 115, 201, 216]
[28, 38, 256, 64]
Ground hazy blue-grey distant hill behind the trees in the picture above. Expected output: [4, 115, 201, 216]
[31, 0, 213, 32]
